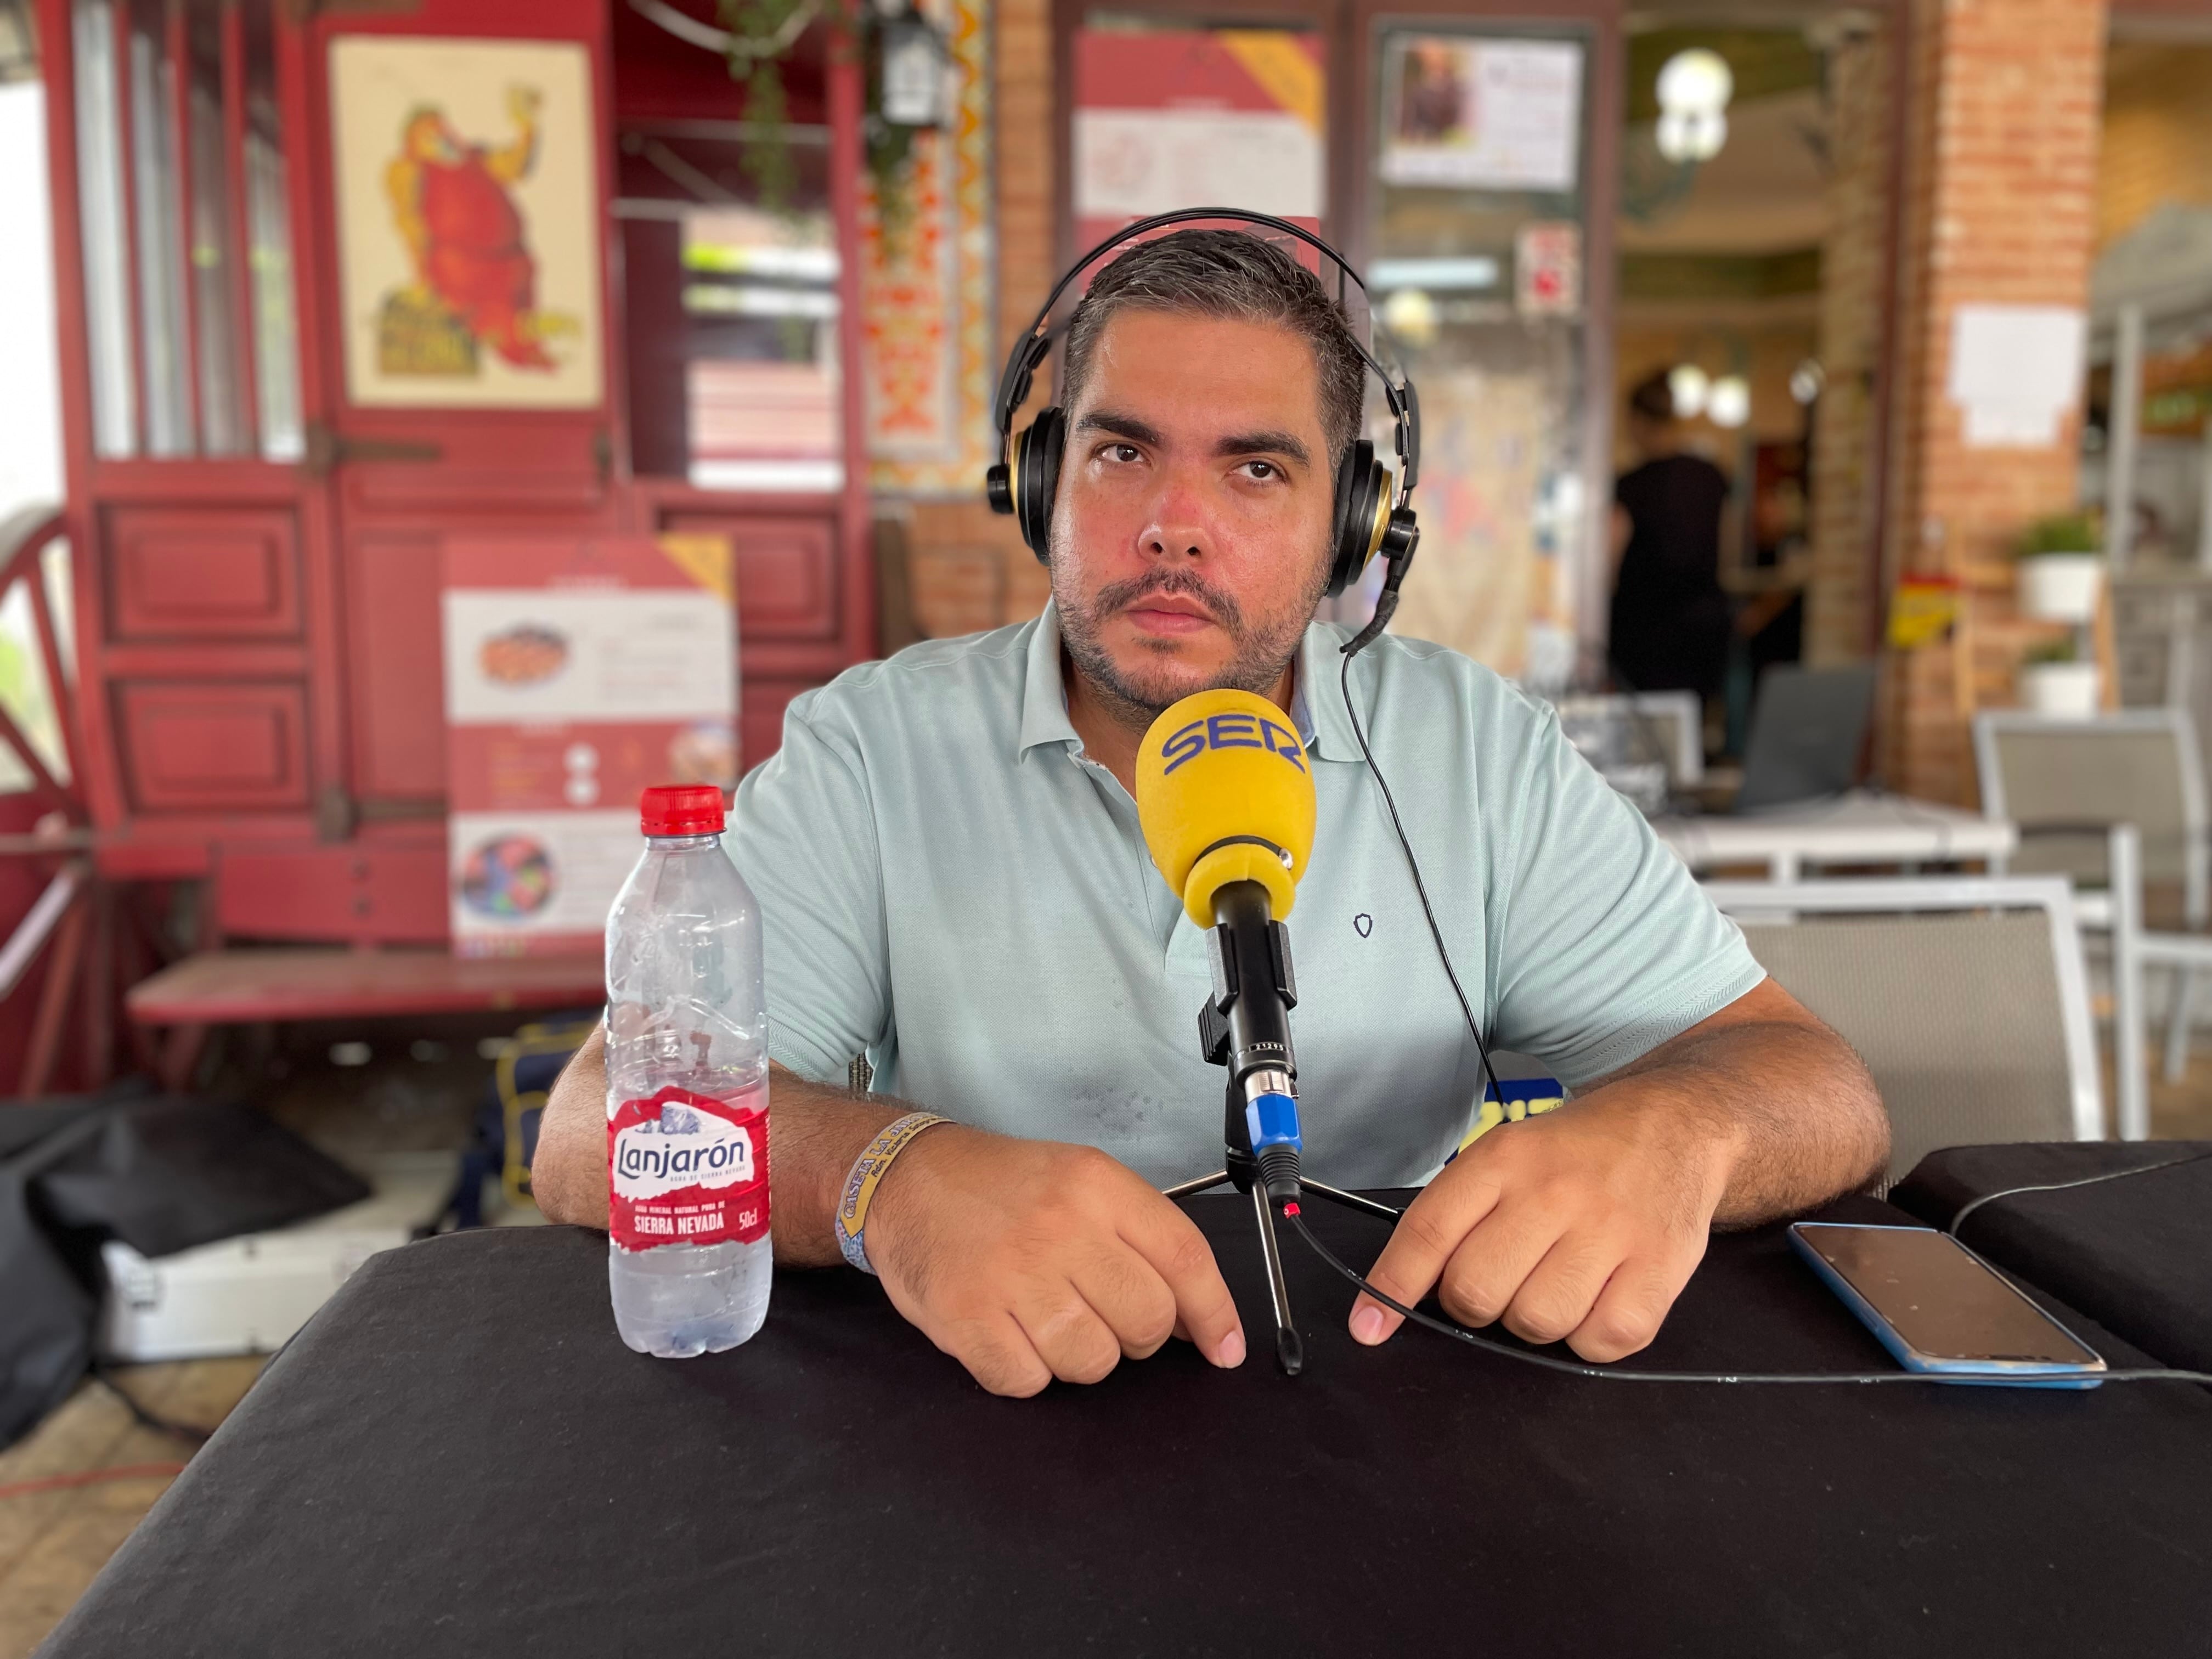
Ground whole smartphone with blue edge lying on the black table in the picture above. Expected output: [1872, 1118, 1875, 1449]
[1790, 1221, 2106, 1389]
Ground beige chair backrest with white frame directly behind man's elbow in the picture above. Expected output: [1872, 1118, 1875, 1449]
[1706, 876, 2103, 1179]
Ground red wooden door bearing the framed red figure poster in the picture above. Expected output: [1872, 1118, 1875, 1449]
[294, 0, 624, 825]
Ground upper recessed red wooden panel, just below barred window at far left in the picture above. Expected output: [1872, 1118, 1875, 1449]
[106, 506, 301, 641]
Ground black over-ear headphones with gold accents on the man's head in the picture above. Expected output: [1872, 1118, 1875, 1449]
[984, 208, 1420, 615]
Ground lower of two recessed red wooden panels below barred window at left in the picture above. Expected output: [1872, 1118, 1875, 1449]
[115, 684, 307, 812]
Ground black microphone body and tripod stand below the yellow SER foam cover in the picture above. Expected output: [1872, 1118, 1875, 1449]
[1166, 881, 1398, 1376]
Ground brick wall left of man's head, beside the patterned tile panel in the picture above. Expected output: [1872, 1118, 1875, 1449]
[907, 0, 1059, 639]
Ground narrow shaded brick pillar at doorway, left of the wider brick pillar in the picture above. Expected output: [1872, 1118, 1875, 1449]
[1805, 24, 1893, 668]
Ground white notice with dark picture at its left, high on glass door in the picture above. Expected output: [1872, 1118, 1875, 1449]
[1380, 36, 1582, 190]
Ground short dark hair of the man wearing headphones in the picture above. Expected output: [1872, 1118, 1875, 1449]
[1059, 230, 1367, 465]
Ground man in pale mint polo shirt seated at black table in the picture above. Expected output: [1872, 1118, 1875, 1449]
[533, 230, 1887, 1393]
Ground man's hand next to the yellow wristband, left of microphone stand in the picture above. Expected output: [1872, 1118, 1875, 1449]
[867, 1124, 1245, 1396]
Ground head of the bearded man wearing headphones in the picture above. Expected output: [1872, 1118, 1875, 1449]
[1053, 230, 1365, 716]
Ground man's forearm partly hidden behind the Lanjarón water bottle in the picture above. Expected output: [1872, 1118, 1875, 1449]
[531, 1031, 907, 1267]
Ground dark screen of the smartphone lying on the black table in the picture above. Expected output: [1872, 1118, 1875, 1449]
[1798, 1226, 2097, 1365]
